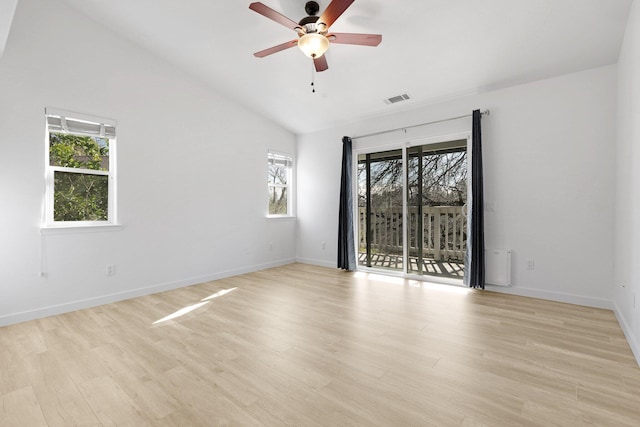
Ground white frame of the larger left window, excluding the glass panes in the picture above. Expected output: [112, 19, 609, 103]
[42, 108, 119, 229]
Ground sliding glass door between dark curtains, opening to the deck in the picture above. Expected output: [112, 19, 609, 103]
[358, 139, 467, 278]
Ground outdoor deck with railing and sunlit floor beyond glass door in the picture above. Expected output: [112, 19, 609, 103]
[358, 206, 467, 278]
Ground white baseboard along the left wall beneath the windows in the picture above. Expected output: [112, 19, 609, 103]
[0, 259, 296, 326]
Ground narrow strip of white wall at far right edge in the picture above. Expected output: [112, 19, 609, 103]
[614, 1, 640, 362]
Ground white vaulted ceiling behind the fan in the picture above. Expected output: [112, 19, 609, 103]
[65, 0, 632, 134]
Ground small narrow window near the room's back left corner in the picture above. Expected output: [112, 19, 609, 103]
[268, 151, 293, 216]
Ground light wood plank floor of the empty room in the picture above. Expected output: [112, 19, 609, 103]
[0, 264, 640, 427]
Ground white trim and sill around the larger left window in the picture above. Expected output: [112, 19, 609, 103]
[40, 108, 122, 234]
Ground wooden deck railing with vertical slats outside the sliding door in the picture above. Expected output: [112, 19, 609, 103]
[358, 206, 467, 261]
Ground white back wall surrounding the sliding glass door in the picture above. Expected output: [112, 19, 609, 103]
[297, 66, 616, 308]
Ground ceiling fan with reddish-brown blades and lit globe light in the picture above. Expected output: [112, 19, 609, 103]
[249, 0, 382, 71]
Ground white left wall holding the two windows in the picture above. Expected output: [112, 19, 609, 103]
[0, 0, 295, 325]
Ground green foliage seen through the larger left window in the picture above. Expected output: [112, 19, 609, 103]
[49, 132, 109, 221]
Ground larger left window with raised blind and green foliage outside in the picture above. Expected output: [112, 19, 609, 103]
[45, 109, 116, 226]
